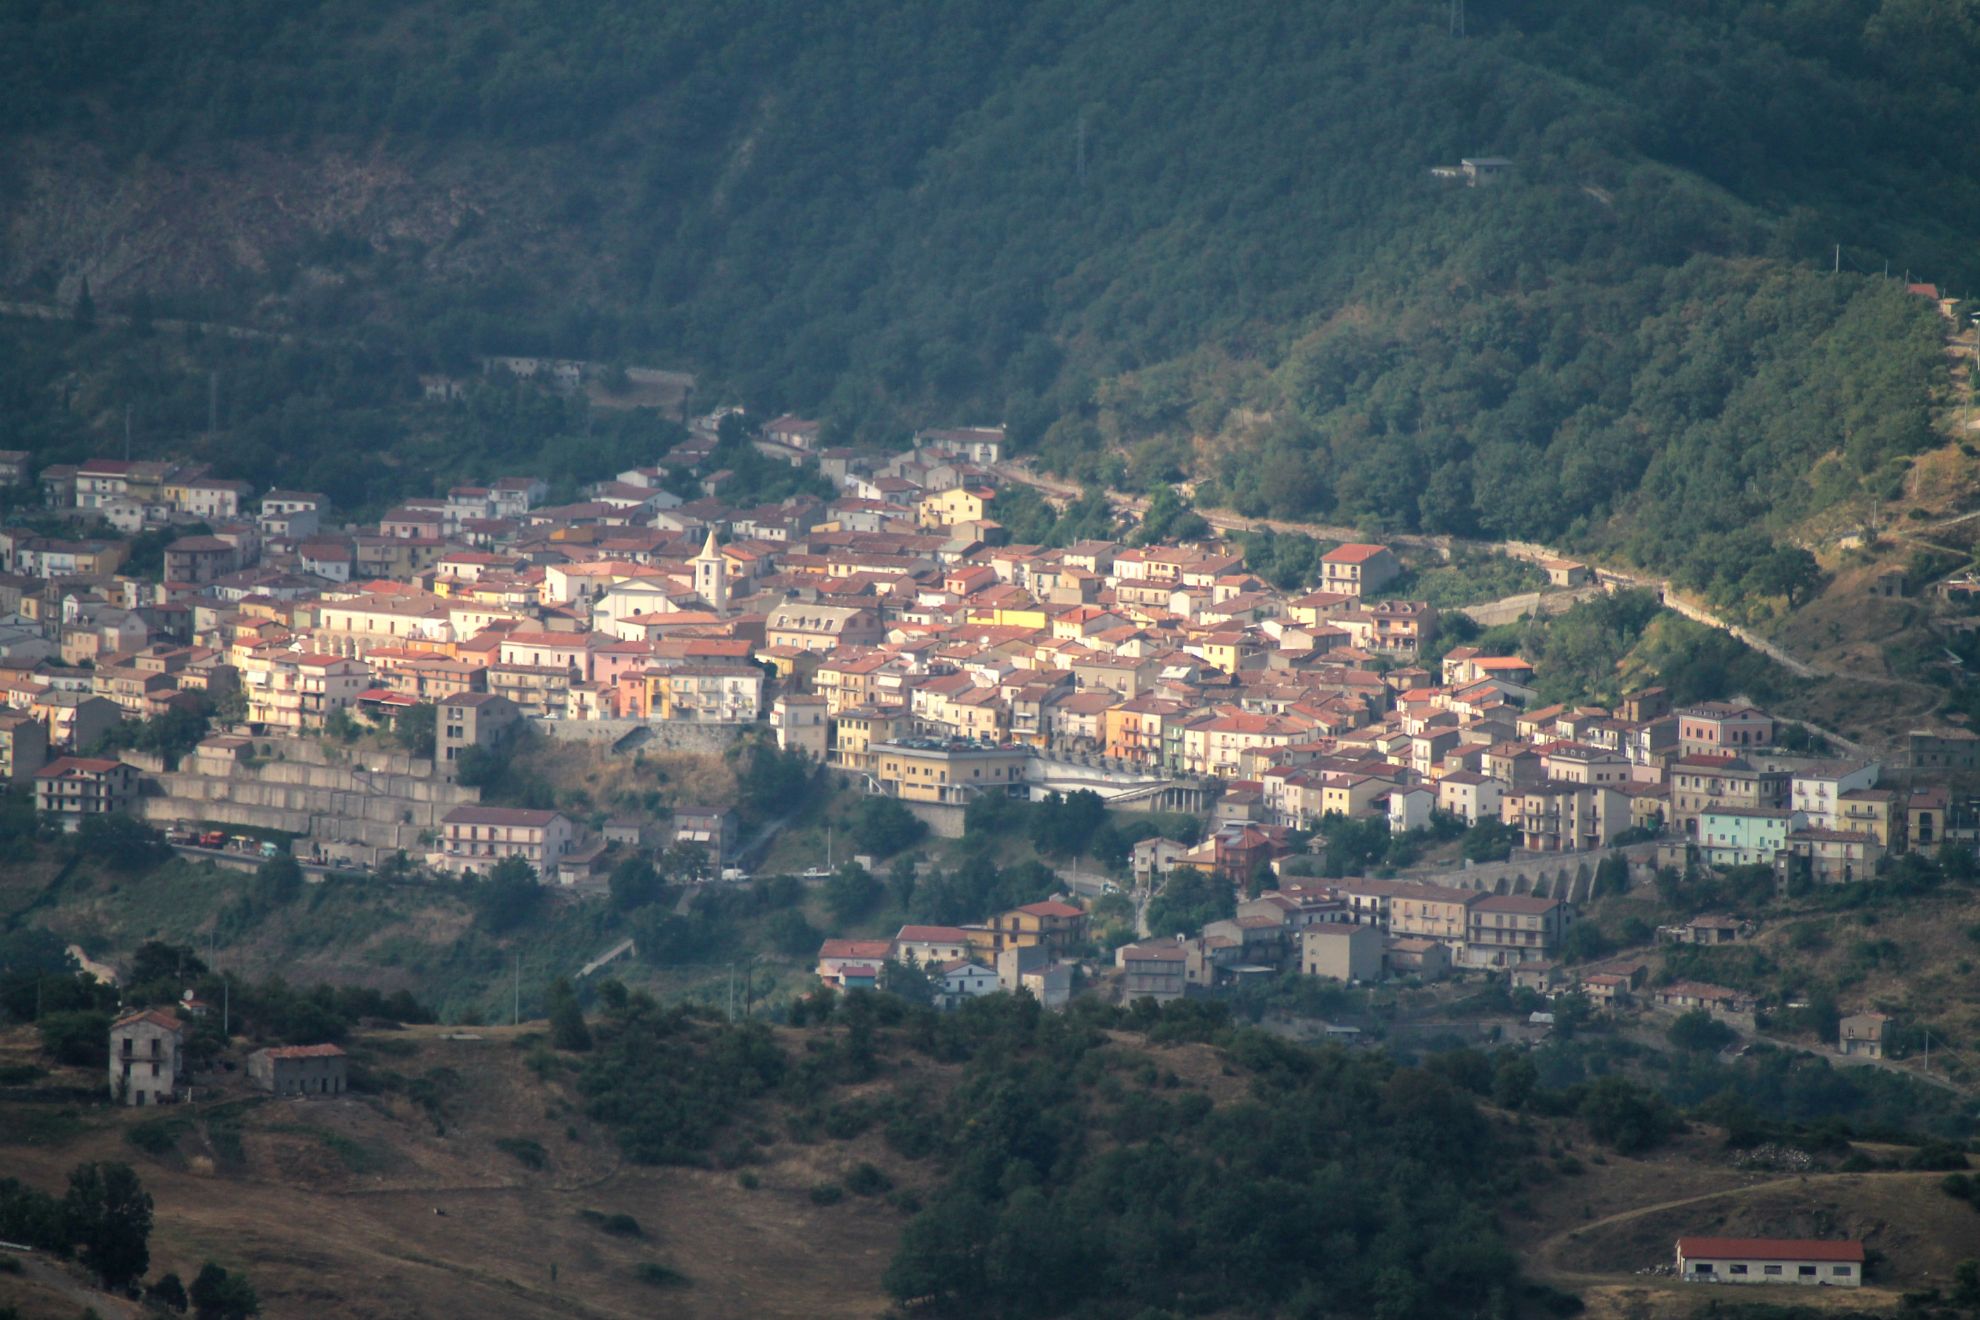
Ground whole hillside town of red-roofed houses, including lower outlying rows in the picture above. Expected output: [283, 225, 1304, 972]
[0, 410, 1980, 1031]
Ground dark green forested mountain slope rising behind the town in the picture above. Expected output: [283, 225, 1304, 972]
[0, 0, 1980, 564]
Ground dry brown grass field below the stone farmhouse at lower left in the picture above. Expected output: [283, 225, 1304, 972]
[0, 1027, 910, 1320]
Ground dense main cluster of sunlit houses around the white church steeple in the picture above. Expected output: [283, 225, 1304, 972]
[0, 403, 1976, 881]
